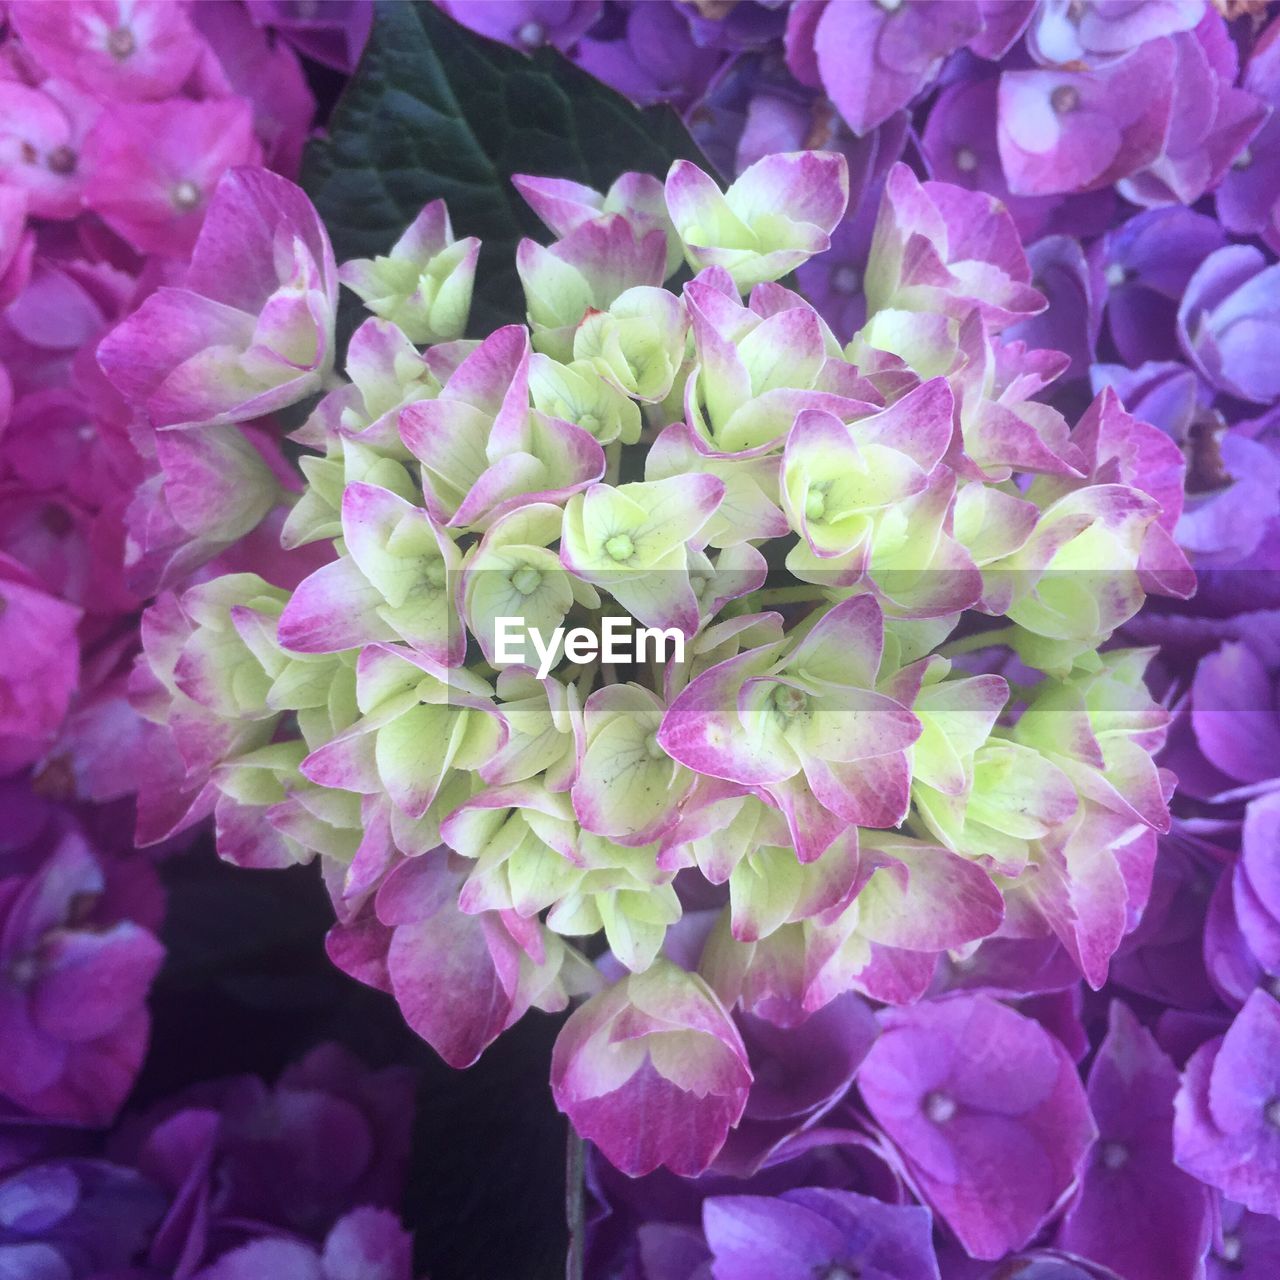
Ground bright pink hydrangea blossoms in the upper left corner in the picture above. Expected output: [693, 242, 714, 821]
[0, 0, 369, 803]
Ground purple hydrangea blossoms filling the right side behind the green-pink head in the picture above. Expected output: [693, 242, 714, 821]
[419, 0, 1280, 1280]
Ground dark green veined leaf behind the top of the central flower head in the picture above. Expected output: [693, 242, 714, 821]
[302, 0, 709, 335]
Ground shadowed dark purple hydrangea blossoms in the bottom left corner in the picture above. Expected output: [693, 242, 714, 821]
[0, 1044, 413, 1280]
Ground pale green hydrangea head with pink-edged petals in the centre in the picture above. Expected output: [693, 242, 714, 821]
[101, 145, 1194, 1172]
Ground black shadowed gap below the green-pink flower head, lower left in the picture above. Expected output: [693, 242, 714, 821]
[129, 837, 567, 1280]
